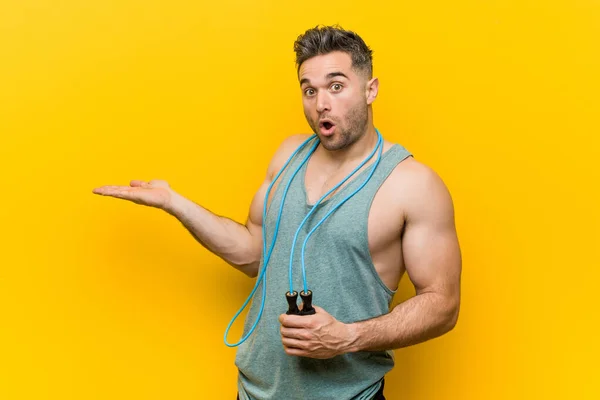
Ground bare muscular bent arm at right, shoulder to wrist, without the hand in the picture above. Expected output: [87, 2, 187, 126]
[349, 164, 462, 351]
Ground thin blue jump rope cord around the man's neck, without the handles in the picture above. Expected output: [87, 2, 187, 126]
[223, 129, 383, 347]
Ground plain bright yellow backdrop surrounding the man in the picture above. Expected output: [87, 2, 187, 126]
[0, 0, 600, 400]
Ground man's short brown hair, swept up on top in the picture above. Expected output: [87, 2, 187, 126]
[294, 25, 373, 79]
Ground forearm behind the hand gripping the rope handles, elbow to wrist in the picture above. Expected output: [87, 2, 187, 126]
[348, 292, 458, 351]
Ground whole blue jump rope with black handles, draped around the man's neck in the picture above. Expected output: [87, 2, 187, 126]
[223, 128, 383, 347]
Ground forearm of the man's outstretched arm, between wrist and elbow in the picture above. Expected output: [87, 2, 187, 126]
[165, 193, 260, 276]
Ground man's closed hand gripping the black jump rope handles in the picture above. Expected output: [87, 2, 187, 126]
[279, 306, 352, 358]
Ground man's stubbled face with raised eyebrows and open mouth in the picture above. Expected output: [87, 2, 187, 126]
[298, 51, 372, 150]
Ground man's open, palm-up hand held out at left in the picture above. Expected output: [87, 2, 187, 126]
[92, 179, 173, 208]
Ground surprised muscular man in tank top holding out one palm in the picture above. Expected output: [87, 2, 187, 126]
[94, 26, 461, 399]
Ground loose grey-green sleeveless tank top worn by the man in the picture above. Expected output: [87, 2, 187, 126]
[235, 138, 412, 400]
